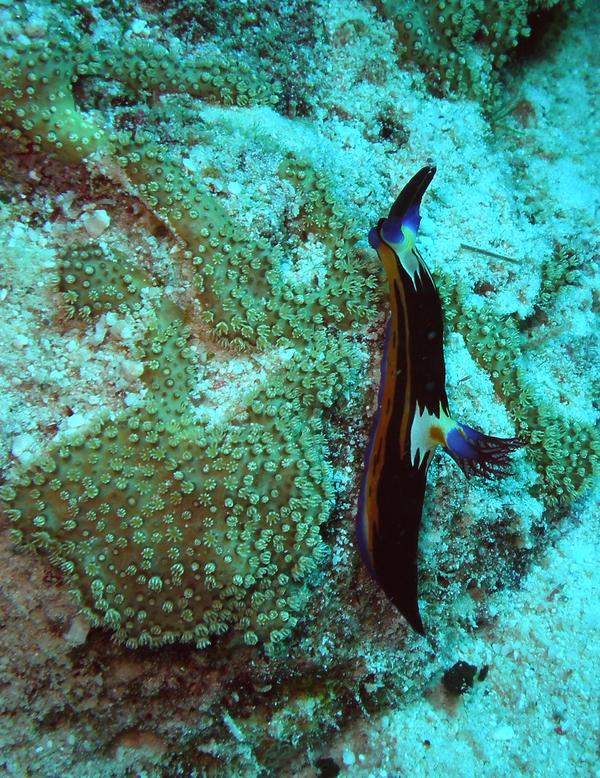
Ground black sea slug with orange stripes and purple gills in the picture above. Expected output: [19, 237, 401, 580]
[357, 166, 522, 635]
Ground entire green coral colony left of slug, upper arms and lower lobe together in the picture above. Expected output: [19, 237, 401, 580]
[1, 4, 377, 649]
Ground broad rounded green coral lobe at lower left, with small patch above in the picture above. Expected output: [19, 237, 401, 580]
[2, 244, 332, 647]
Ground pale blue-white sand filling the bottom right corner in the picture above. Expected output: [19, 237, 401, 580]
[316, 506, 600, 778]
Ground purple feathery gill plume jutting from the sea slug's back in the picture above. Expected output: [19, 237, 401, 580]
[444, 422, 523, 478]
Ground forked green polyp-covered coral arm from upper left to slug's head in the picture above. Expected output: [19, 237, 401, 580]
[0, 0, 376, 349]
